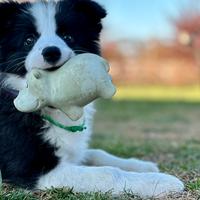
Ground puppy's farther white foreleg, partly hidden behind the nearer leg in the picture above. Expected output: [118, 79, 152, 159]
[86, 149, 159, 172]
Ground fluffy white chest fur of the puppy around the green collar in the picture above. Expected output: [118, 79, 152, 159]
[43, 111, 90, 164]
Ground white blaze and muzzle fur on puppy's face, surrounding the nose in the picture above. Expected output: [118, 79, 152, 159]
[25, 0, 74, 72]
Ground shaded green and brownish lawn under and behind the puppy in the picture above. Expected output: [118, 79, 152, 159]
[0, 85, 200, 200]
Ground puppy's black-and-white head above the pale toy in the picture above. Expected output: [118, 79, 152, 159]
[0, 0, 106, 75]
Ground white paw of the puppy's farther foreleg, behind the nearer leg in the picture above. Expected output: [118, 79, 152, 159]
[123, 158, 159, 172]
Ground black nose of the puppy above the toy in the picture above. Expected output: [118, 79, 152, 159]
[42, 46, 61, 64]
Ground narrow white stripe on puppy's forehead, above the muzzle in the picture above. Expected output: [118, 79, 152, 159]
[31, 1, 56, 35]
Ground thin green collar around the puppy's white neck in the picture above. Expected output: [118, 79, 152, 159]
[42, 115, 86, 133]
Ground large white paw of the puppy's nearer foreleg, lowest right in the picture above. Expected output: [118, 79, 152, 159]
[125, 173, 184, 198]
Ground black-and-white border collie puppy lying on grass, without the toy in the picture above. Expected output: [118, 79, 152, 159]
[0, 0, 183, 197]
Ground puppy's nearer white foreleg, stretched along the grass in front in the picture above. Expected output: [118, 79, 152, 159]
[36, 164, 184, 197]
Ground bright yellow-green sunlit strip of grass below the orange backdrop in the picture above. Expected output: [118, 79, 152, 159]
[115, 85, 200, 102]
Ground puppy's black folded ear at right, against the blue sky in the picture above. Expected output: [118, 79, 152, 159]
[75, 0, 107, 23]
